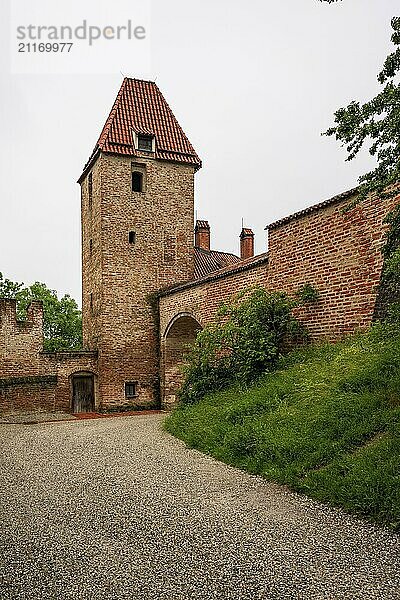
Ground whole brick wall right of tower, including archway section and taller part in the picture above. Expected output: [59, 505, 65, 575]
[160, 195, 399, 403]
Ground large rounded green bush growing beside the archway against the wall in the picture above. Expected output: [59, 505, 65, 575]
[180, 287, 304, 404]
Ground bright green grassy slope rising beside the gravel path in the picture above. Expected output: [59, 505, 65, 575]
[165, 326, 400, 530]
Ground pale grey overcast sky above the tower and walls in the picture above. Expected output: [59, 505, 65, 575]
[0, 0, 399, 302]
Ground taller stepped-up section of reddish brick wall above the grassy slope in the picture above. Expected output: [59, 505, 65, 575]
[266, 191, 396, 340]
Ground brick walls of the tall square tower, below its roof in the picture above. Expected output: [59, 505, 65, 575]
[82, 154, 198, 406]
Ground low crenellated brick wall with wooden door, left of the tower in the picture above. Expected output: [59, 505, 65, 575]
[0, 300, 98, 414]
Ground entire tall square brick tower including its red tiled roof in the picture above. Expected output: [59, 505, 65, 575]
[79, 78, 201, 407]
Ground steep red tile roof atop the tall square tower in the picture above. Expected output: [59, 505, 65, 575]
[79, 77, 201, 178]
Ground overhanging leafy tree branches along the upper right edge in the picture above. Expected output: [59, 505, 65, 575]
[324, 17, 400, 316]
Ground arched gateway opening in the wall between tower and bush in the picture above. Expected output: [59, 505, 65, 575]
[163, 314, 201, 405]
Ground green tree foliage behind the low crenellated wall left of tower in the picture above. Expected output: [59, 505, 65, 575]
[0, 273, 82, 352]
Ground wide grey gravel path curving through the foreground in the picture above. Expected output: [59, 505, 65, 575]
[0, 415, 400, 600]
